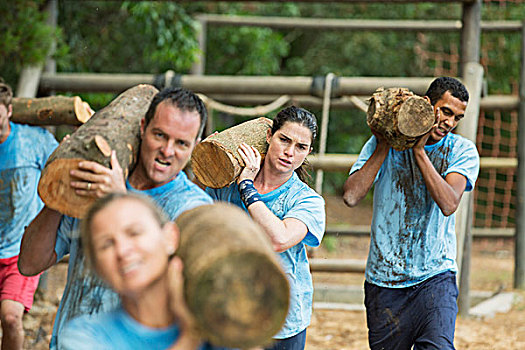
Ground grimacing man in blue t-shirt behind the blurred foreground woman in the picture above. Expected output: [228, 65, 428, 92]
[19, 88, 212, 349]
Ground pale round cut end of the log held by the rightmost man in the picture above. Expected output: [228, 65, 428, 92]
[398, 96, 435, 137]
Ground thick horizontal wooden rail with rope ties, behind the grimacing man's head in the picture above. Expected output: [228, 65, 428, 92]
[39, 72, 434, 97]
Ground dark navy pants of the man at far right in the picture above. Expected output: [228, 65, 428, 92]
[365, 271, 458, 350]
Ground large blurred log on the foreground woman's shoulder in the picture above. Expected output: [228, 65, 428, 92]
[176, 203, 290, 349]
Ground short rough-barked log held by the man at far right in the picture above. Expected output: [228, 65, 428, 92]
[366, 88, 435, 151]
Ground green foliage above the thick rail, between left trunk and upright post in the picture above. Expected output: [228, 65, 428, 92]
[59, 1, 199, 73]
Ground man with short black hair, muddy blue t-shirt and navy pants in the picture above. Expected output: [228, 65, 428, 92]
[344, 77, 479, 349]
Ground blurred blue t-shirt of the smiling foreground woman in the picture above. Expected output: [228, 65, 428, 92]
[59, 307, 179, 350]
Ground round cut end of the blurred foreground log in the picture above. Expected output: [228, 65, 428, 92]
[187, 251, 289, 348]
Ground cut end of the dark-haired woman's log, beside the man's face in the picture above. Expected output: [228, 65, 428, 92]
[191, 141, 240, 188]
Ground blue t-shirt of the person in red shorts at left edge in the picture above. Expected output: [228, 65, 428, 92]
[0, 122, 58, 259]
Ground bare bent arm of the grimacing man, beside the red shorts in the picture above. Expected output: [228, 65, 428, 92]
[18, 207, 62, 276]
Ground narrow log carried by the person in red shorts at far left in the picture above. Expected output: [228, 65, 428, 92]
[11, 96, 94, 126]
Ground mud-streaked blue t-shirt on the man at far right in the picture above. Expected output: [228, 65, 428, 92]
[350, 133, 479, 288]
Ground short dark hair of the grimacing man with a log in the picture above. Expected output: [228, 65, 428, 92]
[144, 87, 208, 138]
